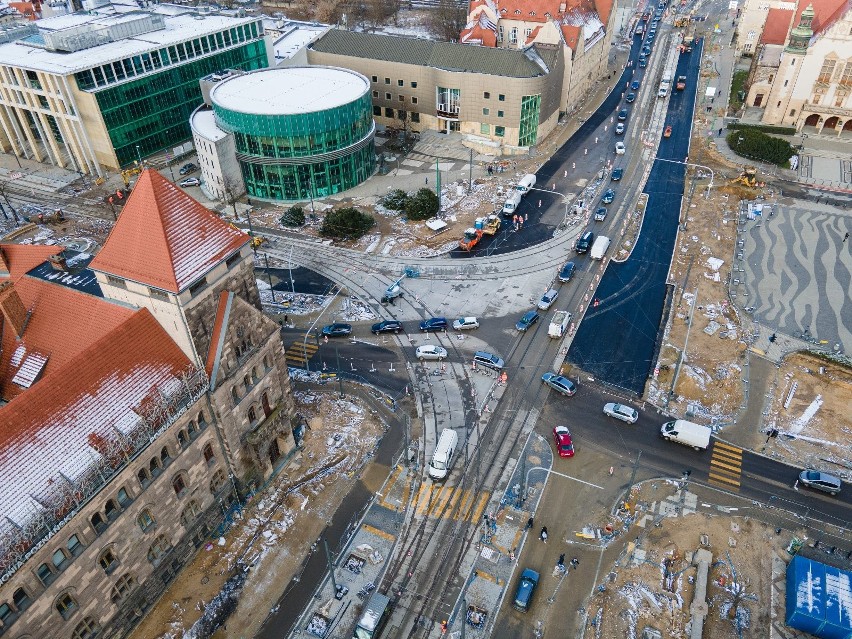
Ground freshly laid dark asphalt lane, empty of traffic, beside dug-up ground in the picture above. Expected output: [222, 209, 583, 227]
[567, 41, 703, 395]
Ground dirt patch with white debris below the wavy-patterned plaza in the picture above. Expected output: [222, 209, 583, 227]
[765, 353, 852, 470]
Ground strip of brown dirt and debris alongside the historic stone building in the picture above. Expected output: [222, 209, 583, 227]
[130, 393, 383, 639]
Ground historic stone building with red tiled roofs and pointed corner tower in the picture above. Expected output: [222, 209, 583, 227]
[0, 170, 294, 639]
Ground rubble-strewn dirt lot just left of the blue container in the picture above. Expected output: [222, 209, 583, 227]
[583, 488, 791, 639]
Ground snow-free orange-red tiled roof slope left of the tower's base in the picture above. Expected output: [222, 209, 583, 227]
[0, 278, 133, 402]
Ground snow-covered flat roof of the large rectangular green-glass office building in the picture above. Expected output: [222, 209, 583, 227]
[0, 13, 258, 74]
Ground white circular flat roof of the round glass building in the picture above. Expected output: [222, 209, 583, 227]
[210, 66, 370, 115]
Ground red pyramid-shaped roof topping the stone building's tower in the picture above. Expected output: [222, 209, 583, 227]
[89, 169, 249, 293]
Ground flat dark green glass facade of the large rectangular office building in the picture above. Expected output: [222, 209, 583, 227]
[95, 40, 268, 166]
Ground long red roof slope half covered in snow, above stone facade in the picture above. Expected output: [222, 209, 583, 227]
[0, 308, 190, 522]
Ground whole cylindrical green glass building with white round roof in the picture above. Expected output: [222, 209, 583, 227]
[210, 66, 376, 200]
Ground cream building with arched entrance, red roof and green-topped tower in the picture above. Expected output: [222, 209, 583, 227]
[746, 0, 852, 138]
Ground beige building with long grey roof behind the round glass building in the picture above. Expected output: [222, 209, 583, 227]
[308, 29, 566, 155]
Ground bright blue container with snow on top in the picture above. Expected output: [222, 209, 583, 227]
[785, 555, 852, 639]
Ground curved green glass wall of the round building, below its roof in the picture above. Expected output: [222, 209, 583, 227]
[213, 85, 376, 200]
